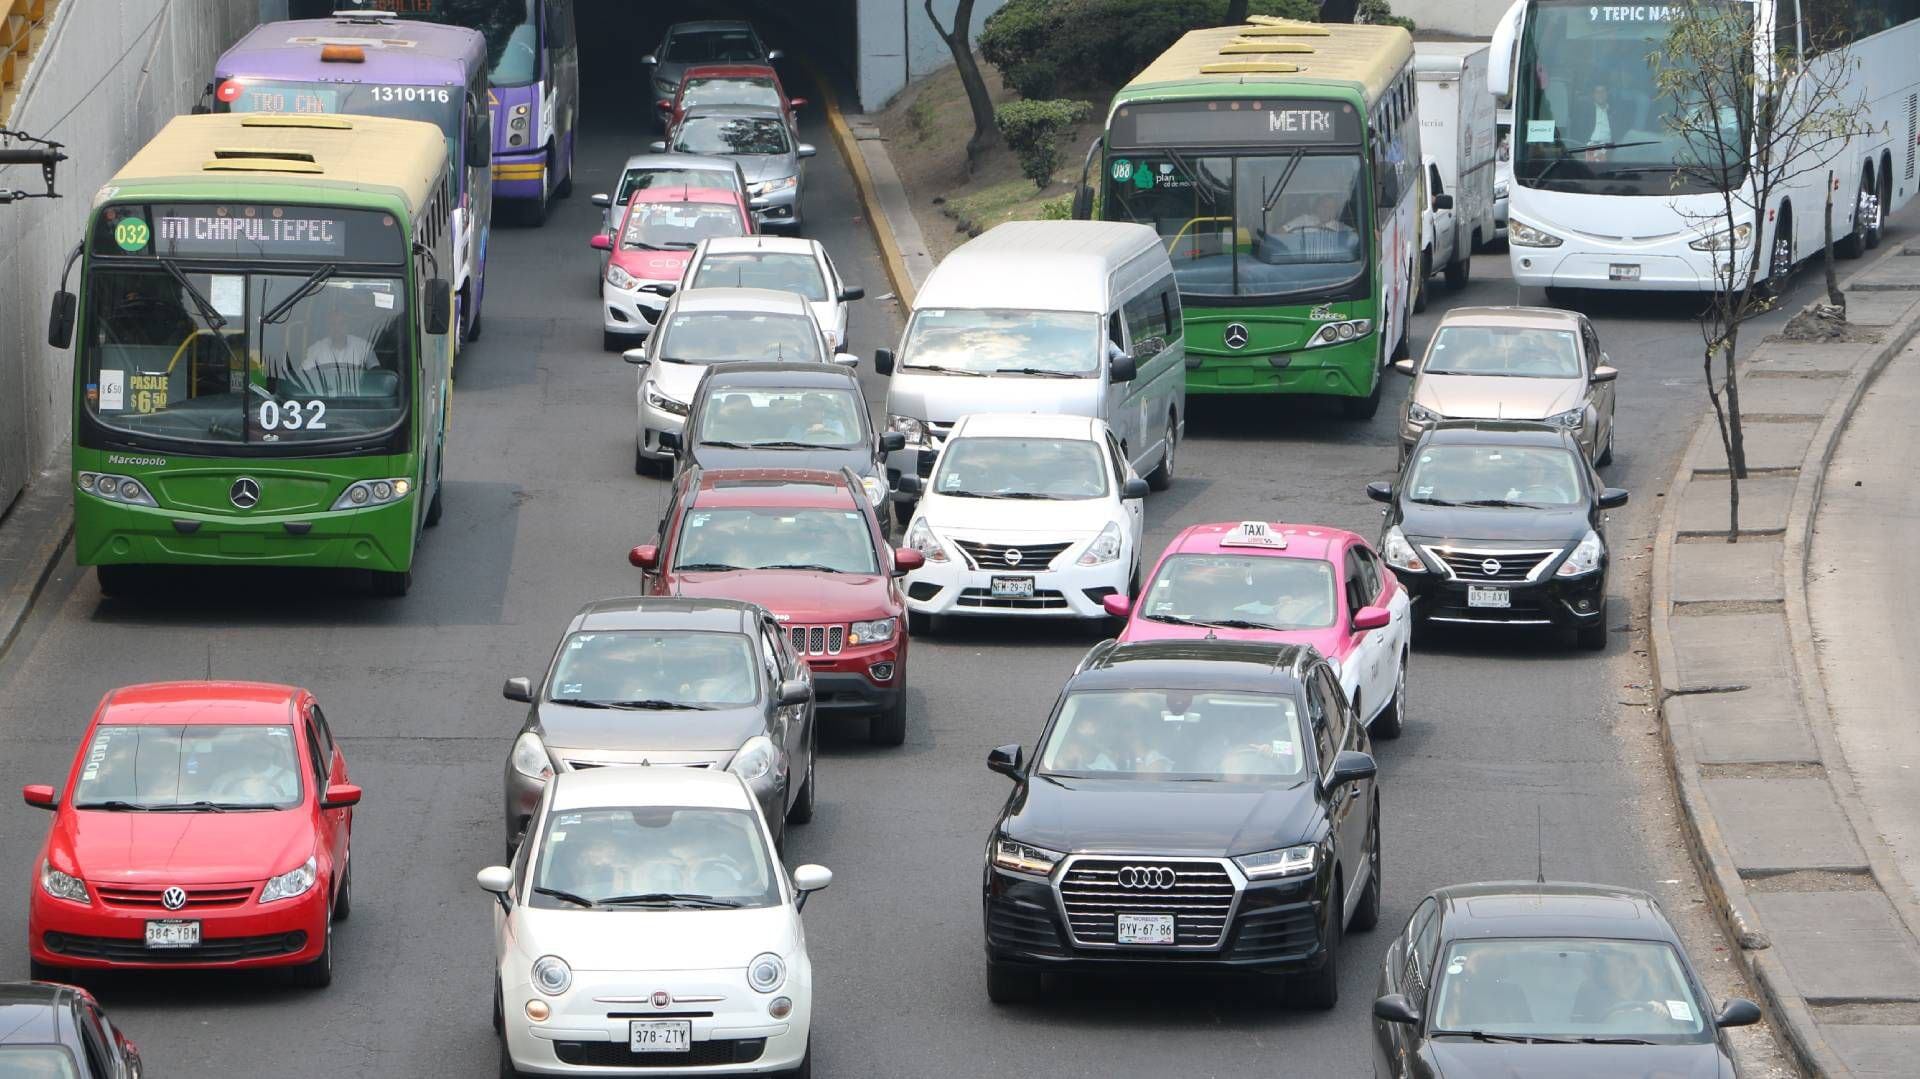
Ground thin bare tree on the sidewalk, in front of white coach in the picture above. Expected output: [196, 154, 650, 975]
[1647, 0, 1860, 543]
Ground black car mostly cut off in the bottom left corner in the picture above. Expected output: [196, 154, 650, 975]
[0, 981, 140, 1079]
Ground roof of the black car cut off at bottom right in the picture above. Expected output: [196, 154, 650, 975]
[1432, 881, 1680, 947]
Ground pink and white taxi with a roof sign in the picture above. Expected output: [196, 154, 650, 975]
[1104, 520, 1413, 737]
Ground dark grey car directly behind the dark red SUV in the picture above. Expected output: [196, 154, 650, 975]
[660, 361, 906, 526]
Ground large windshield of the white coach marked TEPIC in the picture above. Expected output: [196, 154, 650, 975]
[1513, 0, 1753, 196]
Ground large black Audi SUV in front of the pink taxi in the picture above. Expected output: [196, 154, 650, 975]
[985, 641, 1380, 1008]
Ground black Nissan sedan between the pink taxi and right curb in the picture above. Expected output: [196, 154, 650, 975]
[1367, 420, 1626, 649]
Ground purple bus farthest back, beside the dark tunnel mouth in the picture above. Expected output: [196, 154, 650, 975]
[336, 0, 580, 225]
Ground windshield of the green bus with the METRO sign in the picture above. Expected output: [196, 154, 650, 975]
[1106, 150, 1369, 296]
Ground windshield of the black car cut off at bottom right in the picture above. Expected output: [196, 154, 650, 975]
[1428, 933, 1713, 1044]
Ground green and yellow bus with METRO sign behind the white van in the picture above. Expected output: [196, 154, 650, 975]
[1075, 17, 1423, 419]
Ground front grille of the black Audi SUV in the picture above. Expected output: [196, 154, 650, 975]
[1058, 856, 1238, 948]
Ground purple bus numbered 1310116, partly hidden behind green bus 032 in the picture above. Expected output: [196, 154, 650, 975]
[209, 12, 493, 342]
